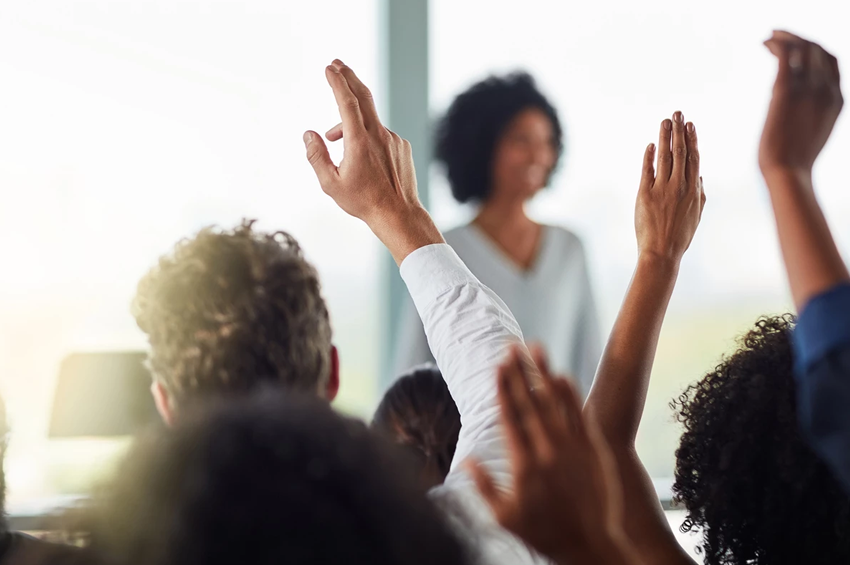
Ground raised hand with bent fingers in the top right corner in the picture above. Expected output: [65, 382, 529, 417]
[759, 31, 844, 177]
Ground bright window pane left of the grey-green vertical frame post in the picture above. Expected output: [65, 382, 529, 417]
[0, 0, 382, 505]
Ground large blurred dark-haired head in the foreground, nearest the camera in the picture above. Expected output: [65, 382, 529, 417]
[93, 391, 470, 565]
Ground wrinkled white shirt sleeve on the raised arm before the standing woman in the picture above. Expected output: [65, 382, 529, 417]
[401, 244, 525, 486]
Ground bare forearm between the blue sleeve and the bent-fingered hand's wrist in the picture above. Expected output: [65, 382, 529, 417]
[764, 172, 850, 312]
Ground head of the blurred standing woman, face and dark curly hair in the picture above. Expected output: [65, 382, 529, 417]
[436, 73, 563, 203]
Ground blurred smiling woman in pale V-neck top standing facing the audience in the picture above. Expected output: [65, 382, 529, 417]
[396, 73, 602, 394]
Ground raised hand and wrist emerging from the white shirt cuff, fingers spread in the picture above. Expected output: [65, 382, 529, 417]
[304, 60, 443, 264]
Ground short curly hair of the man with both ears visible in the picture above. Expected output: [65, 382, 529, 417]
[132, 220, 331, 406]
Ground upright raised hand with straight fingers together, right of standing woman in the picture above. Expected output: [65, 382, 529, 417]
[635, 112, 705, 260]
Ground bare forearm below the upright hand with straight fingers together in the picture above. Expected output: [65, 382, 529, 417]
[584, 256, 679, 449]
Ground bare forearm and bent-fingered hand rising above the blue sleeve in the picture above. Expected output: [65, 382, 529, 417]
[759, 31, 850, 311]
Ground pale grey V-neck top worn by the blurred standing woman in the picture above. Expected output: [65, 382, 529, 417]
[394, 224, 602, 395]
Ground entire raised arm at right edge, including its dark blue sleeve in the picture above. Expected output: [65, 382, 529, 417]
[759, 32, 850, 492]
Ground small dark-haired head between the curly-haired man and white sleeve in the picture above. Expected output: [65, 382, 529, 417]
[372, 365, 460, 488]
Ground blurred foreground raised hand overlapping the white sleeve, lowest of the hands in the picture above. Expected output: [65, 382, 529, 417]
[467, 349, 634, 565]
